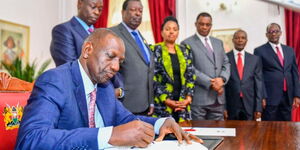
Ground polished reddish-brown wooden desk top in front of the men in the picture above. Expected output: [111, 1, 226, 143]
[181, 121, 300, 150]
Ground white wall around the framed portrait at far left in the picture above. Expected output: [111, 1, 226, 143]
[0, 0, 77, 68]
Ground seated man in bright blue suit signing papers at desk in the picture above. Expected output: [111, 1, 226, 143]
[15, 29, 201, 150]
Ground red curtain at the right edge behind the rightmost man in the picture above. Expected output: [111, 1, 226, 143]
[285, 9, 300, 121]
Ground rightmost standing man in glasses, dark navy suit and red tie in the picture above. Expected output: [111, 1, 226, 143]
[254, 23, 300, 121]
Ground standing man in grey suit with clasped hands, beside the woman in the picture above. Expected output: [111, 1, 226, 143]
[182, 12, 230, 120]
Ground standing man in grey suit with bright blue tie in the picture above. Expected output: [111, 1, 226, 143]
[111, 0, 154, 115]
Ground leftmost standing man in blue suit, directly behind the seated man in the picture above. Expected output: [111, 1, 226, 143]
[50, 0, 124, 99]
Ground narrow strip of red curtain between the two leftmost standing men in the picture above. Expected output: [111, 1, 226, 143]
[94, 0, 109, 28]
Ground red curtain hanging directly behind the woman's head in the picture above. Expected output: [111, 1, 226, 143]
[148, 0, 176, 43]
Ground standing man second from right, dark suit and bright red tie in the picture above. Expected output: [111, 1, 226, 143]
[225, 30, 263, 120]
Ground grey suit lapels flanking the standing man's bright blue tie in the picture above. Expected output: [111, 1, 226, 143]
[118, 23, 151, 64]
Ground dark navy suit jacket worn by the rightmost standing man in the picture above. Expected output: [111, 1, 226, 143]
[254, 43, 300, 105]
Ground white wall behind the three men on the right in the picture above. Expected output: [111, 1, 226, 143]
[177, 0, 285, 53]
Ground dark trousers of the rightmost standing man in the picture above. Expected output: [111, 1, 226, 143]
[262, 92, 291, 121]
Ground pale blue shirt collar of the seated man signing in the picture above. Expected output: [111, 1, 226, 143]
[77, 60, 97, 95]
